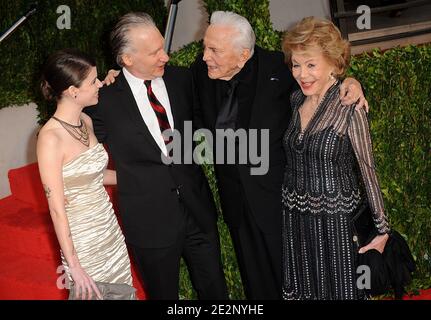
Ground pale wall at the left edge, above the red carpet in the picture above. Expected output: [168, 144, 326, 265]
[0, 103, 39, 199]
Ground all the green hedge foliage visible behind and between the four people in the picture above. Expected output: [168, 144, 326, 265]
[0, 0, 431, 299]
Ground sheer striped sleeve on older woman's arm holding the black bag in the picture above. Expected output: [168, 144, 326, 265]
[348, 108, 390, 234]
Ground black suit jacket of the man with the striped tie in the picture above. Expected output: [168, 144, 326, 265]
[86, 66, 217, 248]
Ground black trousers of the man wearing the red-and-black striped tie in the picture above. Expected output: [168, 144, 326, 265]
[131, 212, 228, 300]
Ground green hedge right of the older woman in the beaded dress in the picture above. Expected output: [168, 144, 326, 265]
[349, 44, 431, 288]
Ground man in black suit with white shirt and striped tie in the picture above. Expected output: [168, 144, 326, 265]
[88, 13, 228, 299]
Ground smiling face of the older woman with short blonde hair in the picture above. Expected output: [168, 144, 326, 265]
[292, 47, 335, 96]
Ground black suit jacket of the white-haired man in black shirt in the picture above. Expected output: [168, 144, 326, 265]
[192, 47, 295, 234]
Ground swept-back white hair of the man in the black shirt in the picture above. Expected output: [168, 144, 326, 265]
[210, 11, 256, 57]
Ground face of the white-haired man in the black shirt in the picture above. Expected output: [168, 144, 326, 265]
[203, 25, 250, 80]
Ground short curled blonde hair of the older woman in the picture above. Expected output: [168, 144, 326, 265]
[282, 17, 350, 78]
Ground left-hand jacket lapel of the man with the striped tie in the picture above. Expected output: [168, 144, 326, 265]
[117, 72, 161, 153]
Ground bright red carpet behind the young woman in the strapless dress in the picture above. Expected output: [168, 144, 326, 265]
[0, 164, 145, 300]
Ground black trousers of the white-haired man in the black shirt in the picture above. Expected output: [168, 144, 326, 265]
[229, 205, 282, 300]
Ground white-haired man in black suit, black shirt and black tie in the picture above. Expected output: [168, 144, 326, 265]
[191, 11, 364, 299]
